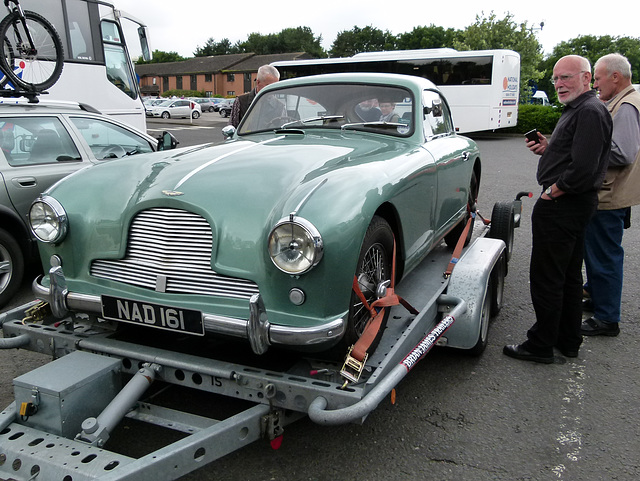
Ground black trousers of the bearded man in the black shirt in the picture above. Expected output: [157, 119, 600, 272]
[525, 192, 598, 355]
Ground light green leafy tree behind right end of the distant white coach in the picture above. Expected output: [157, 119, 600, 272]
[454, 12, 544, 102]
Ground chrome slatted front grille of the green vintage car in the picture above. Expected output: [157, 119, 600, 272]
[91, 208, 258, 299]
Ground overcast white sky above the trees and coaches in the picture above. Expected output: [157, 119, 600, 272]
[111, 0, 640, 57]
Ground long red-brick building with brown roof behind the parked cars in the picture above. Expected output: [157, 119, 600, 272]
[136, 52, 311, 97]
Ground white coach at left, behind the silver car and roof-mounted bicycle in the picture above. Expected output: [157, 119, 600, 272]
[9, 0, 150, 132]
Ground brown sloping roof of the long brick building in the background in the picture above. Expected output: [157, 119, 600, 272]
[136, 52, 312, 77]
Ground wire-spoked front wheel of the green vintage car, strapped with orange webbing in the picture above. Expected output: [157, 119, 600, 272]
[341, 216, 393, 355]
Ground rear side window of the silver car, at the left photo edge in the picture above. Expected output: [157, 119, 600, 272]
[0, 117, 82, 167]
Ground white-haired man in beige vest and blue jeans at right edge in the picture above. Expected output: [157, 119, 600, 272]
[580, 53, 640, 336]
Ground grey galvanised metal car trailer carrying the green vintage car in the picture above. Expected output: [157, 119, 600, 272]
[0, 193, 530, 481]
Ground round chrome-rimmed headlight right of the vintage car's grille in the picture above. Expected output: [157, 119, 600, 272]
[269, 217, 323, 275]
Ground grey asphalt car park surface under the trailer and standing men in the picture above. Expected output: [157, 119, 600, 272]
[0, 133, 640, 481]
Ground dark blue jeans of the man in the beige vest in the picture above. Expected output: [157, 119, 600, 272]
[584, 208, 627, 322]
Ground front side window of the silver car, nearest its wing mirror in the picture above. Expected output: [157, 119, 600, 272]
[70, 116, 154, 160]
